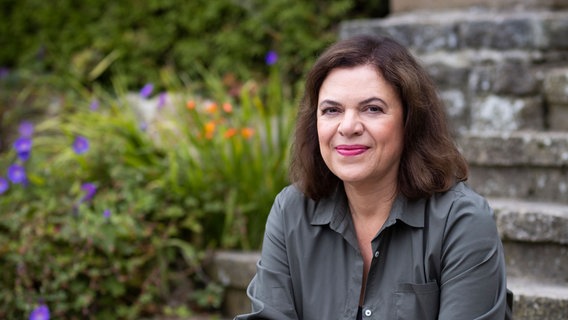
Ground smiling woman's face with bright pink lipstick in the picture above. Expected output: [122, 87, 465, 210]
[317, 65, 404, 187]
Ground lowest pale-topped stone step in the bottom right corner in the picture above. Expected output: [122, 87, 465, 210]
[507, 277, 568, 320]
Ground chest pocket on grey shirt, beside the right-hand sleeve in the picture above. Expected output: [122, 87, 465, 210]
[393, 281, 440, 320]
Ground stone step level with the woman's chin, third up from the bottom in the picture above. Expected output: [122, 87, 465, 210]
[457, 131, 568, 204]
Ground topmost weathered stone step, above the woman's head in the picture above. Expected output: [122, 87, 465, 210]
[339, 9, 568, 52]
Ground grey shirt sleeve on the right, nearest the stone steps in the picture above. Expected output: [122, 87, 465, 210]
[438, 191, 507, 319]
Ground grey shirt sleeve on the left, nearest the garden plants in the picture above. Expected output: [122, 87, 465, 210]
[235, 188, 298, 320]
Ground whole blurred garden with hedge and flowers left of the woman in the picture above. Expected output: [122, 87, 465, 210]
[0, 0, 388, 319]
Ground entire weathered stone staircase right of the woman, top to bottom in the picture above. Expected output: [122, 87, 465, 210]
[340, 5, 568, 320]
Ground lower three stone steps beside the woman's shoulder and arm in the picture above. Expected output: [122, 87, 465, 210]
[460, 131, 568, 320]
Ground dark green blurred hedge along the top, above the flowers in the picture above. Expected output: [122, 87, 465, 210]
[0, 0, 386, 87]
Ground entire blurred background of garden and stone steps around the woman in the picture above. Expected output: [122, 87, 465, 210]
[0, 0, 568, 320]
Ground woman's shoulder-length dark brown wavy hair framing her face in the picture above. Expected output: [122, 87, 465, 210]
[290, 35, 468, 200]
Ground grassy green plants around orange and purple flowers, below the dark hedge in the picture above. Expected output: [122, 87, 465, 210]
[0, 66, 295, 319]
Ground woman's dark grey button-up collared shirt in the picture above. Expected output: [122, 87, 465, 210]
[235, 183, 506, 320]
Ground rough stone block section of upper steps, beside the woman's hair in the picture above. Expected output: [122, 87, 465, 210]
[340, 8, 568, 132]
